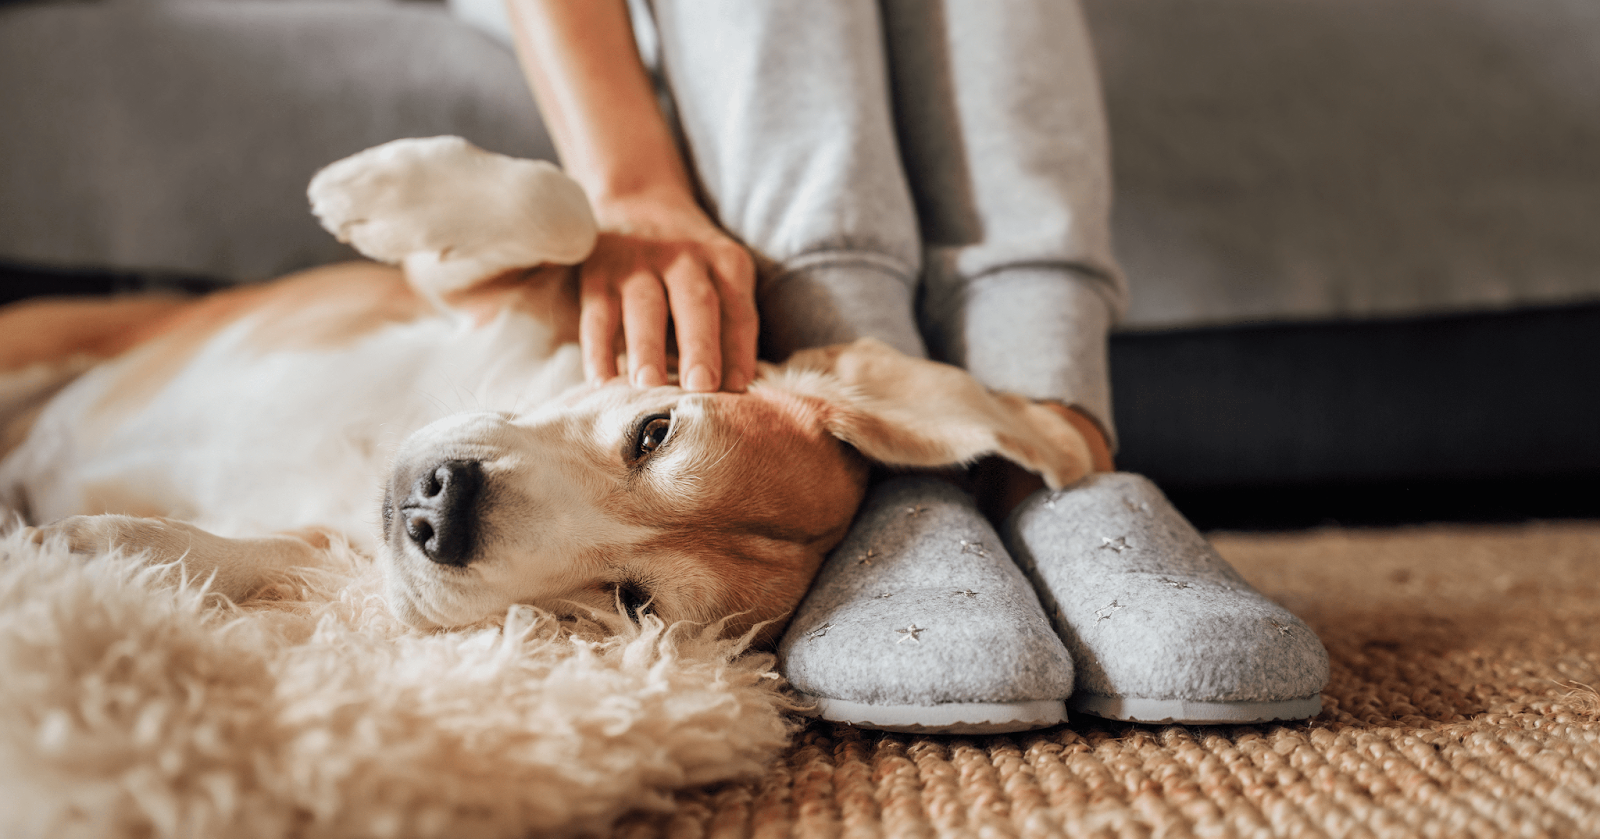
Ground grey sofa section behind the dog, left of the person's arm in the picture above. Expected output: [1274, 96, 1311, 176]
[0, 0, 554, 280]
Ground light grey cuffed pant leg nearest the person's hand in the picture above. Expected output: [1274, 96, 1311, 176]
[653, 0, 923, 359]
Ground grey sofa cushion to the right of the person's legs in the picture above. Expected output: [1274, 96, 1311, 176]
[1085, 0, 1600, 328]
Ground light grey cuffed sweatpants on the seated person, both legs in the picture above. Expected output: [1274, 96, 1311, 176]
[635, 0, 1126, 434]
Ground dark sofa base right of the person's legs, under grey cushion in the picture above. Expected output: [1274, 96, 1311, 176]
[1110, 304, 1600, 488]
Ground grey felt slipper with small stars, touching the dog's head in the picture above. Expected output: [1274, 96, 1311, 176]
[778, 477, 1072, 733]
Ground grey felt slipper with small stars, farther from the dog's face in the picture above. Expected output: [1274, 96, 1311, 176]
[1005, 472, 1328, 724]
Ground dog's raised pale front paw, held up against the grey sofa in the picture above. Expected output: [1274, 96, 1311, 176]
[307, 136, 597, 299]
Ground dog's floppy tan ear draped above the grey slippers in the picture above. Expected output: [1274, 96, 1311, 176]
[770, 338, 1091, 488]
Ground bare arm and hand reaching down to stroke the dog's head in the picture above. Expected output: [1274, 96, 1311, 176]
[507, 0, 758, 391]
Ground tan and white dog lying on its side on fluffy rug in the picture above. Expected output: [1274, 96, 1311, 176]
[0, 138, 1090, 634]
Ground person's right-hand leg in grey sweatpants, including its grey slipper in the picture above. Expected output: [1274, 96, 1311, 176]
[883, 0, 1328, 722]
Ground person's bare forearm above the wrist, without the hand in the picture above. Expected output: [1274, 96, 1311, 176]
[507, 0, 694, 214]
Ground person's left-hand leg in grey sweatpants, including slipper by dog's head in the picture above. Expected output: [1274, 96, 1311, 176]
[640, 0, 1072, 732]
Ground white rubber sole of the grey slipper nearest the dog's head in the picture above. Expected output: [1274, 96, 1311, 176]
[805, 696, 1067, 735]
